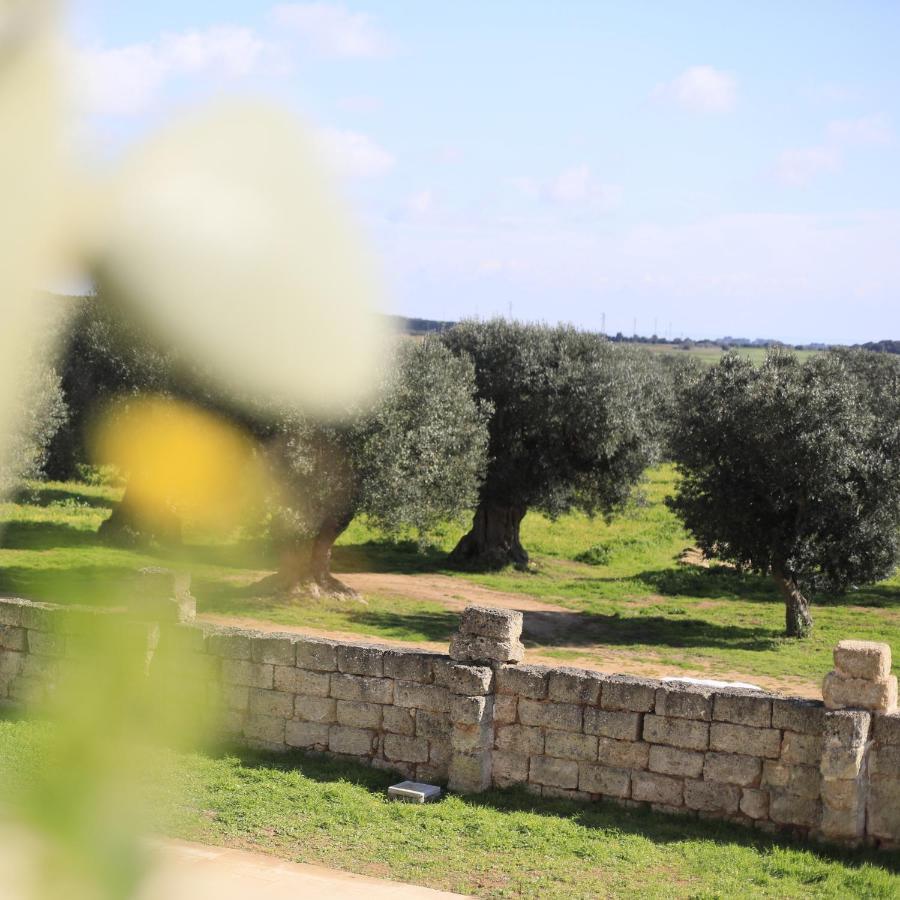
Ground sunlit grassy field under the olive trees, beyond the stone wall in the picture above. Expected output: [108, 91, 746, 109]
[0, 467, 900, 686]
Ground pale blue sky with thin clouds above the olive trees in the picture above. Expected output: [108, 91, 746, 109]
[69, 0, 900, 343]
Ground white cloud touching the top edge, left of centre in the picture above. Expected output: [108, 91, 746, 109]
[272, 3, 391, 58]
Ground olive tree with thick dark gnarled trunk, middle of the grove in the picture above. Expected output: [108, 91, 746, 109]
[442, 319, 663, 568]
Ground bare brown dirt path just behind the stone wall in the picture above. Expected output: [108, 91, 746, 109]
[201, 572, 821, 698]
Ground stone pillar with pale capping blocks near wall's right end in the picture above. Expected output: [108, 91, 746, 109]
[820, 641, 897, 841]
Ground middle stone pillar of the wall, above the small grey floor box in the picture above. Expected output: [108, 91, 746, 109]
[446, 606, 525, 793]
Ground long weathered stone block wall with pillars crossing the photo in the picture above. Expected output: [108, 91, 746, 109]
[0, 601, 900, 847]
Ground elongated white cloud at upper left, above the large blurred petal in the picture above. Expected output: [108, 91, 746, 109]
[74, 25, 267, 116]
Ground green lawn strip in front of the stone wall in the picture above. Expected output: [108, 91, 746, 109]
[0, 721, 900, 900]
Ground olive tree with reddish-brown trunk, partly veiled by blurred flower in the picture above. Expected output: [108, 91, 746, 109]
[258, 337, 489, 595]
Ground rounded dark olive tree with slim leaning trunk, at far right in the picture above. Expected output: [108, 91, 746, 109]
[669, 350, 900, 637]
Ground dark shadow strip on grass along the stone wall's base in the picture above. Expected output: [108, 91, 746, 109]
[223, 746, 900, 872]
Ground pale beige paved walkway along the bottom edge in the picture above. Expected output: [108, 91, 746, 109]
[141, 840, 472, 900]
